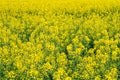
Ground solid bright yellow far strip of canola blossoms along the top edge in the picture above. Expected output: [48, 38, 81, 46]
[0, 0, 120, 10]
